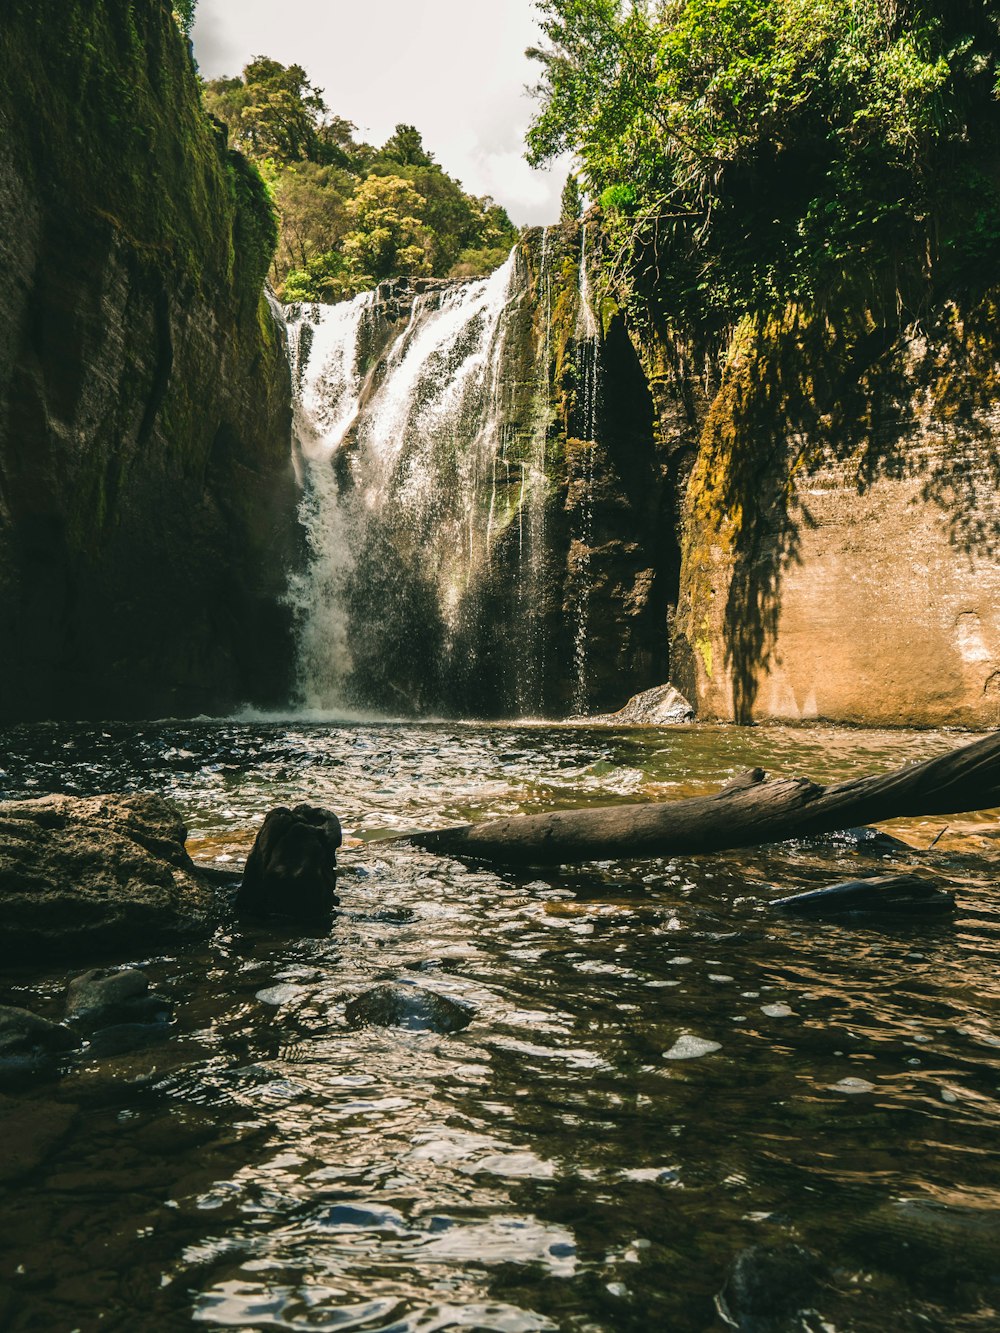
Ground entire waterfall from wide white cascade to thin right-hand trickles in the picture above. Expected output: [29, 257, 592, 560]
[285, 228, 610, 717]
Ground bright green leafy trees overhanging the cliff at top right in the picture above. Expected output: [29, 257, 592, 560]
[528, 0, 1000, 327]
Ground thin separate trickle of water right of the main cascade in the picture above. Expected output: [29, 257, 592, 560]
[572, 223, 600, 714]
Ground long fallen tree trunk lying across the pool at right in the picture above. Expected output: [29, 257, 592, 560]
[407, 732, 1000, 865]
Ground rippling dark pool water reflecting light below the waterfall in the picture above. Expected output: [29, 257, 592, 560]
[0, 722, 1000, 1333]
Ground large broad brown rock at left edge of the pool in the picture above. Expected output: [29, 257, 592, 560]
[0, 796, 215, 962]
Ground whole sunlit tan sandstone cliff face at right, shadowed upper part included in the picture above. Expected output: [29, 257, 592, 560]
[672, 301, 1000, 726]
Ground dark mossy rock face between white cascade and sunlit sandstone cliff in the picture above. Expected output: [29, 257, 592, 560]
[459, 223, 676, 716]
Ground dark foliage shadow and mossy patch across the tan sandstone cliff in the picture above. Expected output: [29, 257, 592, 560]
[693, 299, 1000, 722]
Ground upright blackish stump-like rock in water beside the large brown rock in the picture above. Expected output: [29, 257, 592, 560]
[236, 805, 341, 918]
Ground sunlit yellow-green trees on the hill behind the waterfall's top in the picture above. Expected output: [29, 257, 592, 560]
[204, 56, 517, 301]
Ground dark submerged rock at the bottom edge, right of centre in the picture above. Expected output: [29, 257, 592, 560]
[716, 1245, 820, 1333]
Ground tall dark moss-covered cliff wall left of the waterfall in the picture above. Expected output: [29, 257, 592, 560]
[0, 0, 296, 717]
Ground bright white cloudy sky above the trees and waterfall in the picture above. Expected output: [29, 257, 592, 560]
[193, 0, 567, 225]
